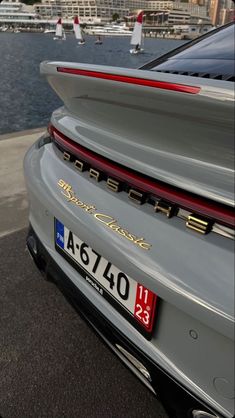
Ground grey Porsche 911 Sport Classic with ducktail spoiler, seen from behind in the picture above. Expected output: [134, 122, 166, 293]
[24, 24, 234, 418]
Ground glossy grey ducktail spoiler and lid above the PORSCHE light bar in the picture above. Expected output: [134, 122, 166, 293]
[41, 62, 234, 206]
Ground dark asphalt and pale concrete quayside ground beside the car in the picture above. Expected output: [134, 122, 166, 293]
[0, 133, 166, 418]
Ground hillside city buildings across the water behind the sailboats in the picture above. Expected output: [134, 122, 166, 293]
[0, 0, 232, 32]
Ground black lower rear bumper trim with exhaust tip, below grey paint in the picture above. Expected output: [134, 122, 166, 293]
[27, 226, 222, 418]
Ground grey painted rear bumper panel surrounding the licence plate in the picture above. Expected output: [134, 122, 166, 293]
[25, 141, 234, 417]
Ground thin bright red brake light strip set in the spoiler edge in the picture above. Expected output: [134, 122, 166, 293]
[57, 67, 201, 94]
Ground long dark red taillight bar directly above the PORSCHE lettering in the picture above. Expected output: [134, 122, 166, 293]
[49, 125, 234, 227]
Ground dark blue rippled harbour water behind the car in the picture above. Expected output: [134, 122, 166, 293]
[0, 32, 184, 134]
